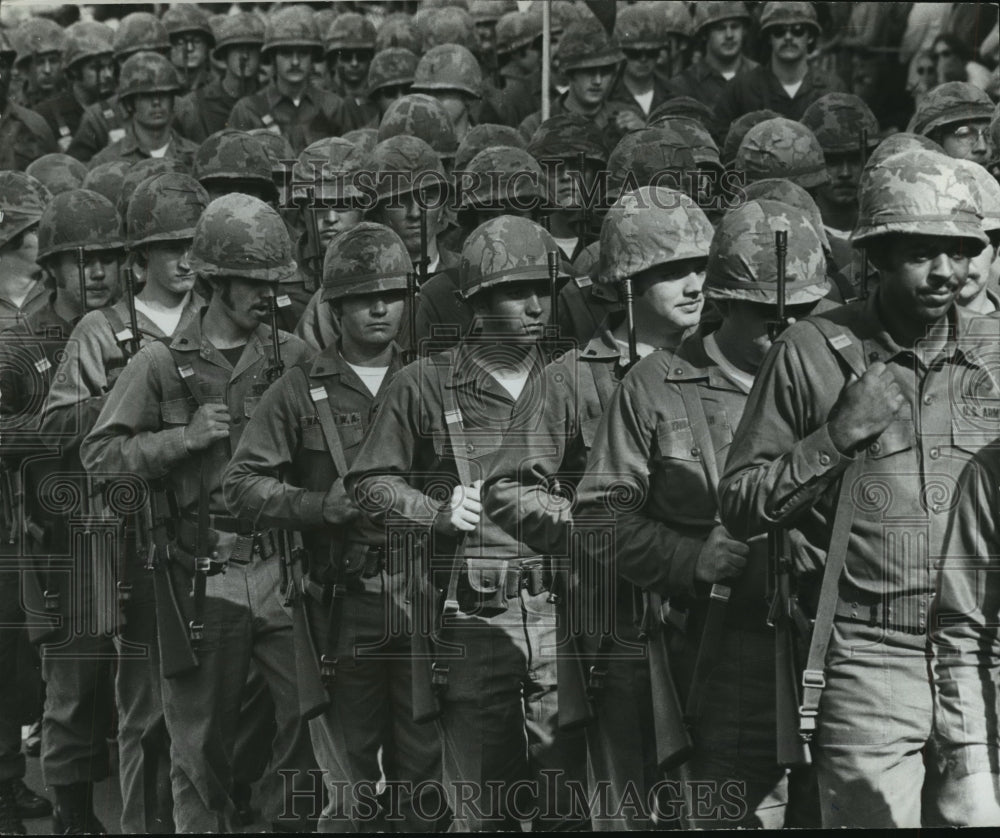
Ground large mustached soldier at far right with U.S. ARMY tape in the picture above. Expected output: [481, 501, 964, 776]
[719, 150, 1000, 828]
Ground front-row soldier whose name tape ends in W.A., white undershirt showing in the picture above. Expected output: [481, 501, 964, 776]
[223, 222, 441, 832]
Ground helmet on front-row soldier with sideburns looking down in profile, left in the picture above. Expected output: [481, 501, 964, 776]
[188, 192, 298, 282]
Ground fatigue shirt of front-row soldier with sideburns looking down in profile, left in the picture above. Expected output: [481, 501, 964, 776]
[80, 310, 308, 516]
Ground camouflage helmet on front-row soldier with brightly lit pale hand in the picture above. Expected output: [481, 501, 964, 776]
[458, 215, 566, 299]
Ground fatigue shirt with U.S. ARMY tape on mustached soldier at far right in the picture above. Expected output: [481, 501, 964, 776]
[720, 296, 1000, 626]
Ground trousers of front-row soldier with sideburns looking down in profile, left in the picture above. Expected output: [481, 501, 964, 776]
[161, 554, 316, 833]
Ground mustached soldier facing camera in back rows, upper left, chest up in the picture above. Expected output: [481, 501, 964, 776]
[229, 6, 342, 154]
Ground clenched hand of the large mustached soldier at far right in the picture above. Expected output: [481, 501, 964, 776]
[828, 361, 906, 454]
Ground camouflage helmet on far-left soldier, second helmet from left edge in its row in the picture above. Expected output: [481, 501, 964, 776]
[38, 189, 125, 259]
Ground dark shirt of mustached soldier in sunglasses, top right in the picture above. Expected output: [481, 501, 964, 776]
[709, 64, 847, 138]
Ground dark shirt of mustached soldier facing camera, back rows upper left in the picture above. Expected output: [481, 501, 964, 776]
[229, 82, 344, 155]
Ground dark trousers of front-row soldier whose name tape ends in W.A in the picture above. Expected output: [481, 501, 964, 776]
[306, 570, 447, 833]
